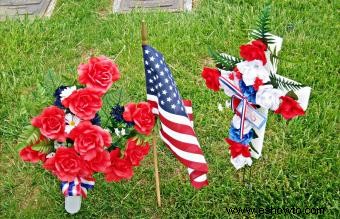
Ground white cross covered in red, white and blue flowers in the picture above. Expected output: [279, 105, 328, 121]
[202, 6, 311, 169]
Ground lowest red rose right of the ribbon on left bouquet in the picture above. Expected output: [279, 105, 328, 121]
[105, 148, 133, 182]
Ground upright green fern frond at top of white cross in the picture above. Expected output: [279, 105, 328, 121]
[250, 5, 274, 45]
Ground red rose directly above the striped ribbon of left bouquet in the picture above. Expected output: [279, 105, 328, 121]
[44, 147, 92, 182]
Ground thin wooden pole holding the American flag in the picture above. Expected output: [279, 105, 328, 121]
[141, 20, 161, 207]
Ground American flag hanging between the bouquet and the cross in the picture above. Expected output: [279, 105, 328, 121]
[143, 45, 208, 189]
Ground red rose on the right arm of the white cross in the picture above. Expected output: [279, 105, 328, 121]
[274, 96, 305, 120]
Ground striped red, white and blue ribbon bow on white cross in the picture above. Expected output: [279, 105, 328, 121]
[219, 76, 266, 139]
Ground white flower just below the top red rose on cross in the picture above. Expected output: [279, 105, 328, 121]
[237, 60, 270, 86]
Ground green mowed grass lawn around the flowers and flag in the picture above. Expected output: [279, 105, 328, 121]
[0, 0, 340, 218]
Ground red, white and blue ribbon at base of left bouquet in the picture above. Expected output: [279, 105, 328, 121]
[61, 177, 94, 198]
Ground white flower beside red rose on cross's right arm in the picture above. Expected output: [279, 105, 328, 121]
[256, 85, 284, 111]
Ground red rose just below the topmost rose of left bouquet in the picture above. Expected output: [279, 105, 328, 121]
[62, 88, 103, 120]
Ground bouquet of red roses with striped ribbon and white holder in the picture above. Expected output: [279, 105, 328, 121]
[19, 56, 155, 213]
